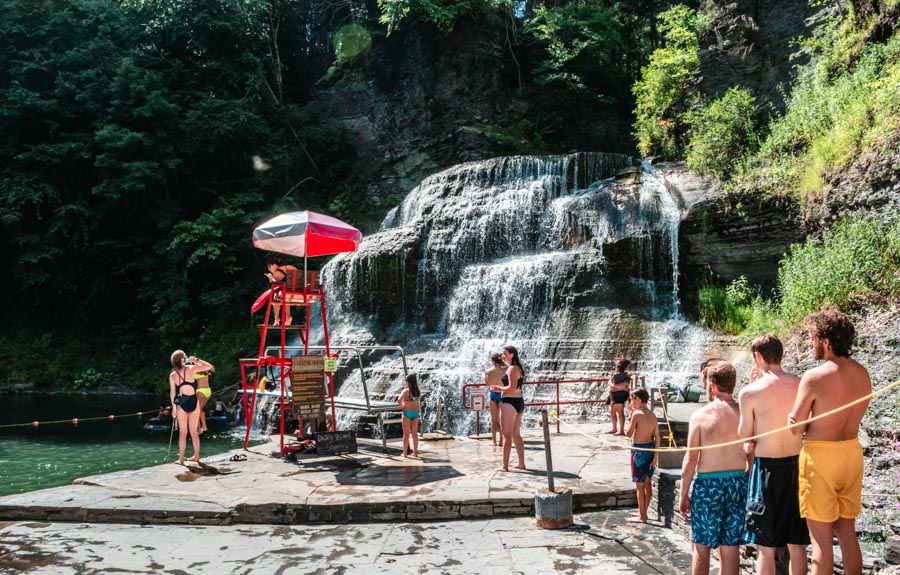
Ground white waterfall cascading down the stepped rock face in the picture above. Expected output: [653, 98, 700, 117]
[316, 154, 709, 433]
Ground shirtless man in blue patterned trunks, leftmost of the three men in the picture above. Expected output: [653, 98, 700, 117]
[678, 361, 747, 575]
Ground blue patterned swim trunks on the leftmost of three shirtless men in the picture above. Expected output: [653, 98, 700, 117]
[691, 469, 747, 549]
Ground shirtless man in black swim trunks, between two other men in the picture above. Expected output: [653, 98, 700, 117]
[738, 333, 809, 575]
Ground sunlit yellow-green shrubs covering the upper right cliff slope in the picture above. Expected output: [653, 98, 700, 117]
[740, 6, 900, 202]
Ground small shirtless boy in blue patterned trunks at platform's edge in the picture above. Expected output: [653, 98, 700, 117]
[625, 389, 659, 523]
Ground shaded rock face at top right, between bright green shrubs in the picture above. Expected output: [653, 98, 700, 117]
[687, 0, 836, 120]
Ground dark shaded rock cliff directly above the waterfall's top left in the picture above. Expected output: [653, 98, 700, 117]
[323, 14, 631, 216]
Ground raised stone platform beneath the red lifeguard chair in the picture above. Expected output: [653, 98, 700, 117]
[0, 422, 648, 525]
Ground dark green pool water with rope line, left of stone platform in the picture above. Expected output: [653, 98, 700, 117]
[0, 394, 262, 495]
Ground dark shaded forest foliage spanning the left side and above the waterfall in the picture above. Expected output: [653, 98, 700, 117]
[0, 0, 696, 388]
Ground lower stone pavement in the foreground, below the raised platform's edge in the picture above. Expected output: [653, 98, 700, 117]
[0, 510, 691, 575]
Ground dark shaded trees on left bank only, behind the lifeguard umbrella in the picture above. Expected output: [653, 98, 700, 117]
[0, 0, 362, 392]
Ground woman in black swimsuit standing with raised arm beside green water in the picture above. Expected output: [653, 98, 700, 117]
[169, 349, 213, 465]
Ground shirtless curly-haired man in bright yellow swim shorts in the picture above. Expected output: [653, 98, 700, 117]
[788, 310, 872, 575]
